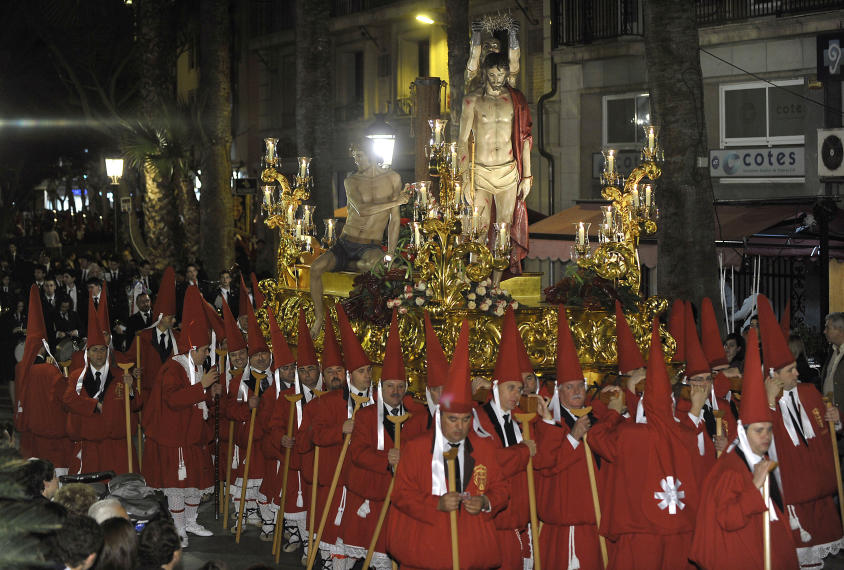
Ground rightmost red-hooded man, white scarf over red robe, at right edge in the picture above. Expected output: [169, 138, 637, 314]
[760, 295, 844, 567]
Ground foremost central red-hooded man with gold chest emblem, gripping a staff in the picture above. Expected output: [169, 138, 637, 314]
[387, 321, 509, 568]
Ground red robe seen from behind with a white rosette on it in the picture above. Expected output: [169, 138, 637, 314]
[588, 411, 699, 570]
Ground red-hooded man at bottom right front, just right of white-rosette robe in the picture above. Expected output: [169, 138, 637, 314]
[690, 329, 797, 570]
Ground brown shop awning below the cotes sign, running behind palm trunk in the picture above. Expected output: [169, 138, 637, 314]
[528, 202, 844, 267]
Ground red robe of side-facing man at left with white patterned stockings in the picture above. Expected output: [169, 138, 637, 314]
[143, 355, 214, 490]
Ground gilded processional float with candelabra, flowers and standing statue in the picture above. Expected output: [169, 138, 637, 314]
[258, 24, 676, 393]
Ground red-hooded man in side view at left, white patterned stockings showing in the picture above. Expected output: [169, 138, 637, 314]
[143, 287, 219, 547]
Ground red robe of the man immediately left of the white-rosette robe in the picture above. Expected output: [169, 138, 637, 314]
[534, 402, 623, 569]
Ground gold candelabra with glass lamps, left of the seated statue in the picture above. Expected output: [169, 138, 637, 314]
[261, 138, 314, 287]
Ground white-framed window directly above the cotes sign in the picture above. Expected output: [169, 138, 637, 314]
[719, 79, 807, 147]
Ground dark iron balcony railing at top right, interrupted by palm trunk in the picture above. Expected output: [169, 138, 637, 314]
[551, 0, 844, 48]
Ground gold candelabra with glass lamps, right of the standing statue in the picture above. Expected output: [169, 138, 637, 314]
[572, 125, 664, 292]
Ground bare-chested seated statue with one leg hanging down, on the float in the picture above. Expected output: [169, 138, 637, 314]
[311, 138, 411, 337]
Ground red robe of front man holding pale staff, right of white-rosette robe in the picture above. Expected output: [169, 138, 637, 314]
[689, 448, 798, 570]
